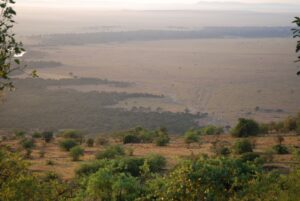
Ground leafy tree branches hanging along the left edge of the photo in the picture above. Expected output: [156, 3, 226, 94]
[0, 0, 37, 91]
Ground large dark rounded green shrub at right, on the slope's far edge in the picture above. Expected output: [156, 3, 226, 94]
[231, 118, 260, 137]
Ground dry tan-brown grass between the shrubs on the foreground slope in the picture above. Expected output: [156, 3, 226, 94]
[0, 135, 300, 179]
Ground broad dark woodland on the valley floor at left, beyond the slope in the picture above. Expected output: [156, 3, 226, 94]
[0, 78, 205, 134]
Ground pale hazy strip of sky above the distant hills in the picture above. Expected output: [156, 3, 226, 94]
[17, 0, 300, 12]
